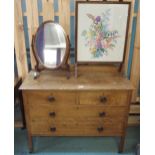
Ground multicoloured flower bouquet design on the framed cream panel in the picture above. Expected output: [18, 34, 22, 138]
[81, 9, 120, 58]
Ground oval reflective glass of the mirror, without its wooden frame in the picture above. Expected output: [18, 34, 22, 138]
[35, 22, 66, 69]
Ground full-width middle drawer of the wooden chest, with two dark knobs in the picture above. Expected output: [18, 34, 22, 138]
[29, 105, 127, 120]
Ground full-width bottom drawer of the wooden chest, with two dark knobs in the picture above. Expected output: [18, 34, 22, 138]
[31, 122, 123, 136]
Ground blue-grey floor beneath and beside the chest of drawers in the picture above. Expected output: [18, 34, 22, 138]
[15, 127, 140, 155]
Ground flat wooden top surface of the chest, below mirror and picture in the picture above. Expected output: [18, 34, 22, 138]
[20, 68, 133, 90]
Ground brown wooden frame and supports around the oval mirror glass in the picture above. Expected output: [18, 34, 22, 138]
[32, 20, 70, 71]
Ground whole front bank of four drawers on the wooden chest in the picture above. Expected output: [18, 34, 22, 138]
[26, 91, 128, 136]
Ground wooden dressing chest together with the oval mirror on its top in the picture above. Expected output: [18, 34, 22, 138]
[20, 21, 133, 152]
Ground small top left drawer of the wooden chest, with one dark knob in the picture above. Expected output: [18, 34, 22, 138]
[27, 91, 77, 106]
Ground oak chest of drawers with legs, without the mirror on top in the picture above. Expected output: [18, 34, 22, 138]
[20, 72, 133, 152]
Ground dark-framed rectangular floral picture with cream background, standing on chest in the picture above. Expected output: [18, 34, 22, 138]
[75, 1, 130, 64]
